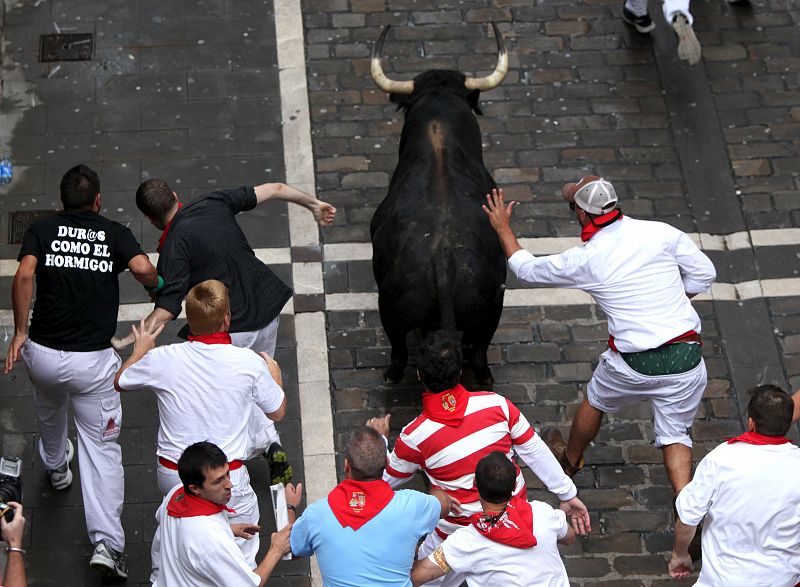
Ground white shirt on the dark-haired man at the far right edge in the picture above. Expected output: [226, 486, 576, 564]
[676, 442, 800, 587]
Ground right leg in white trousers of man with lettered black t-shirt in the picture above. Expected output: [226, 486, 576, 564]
[70, 349, 125, 553]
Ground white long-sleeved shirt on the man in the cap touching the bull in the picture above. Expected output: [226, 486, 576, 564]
[508, 216, 717, 353]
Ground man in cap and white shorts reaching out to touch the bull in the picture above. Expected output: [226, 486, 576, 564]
[483, 176, 716, 493]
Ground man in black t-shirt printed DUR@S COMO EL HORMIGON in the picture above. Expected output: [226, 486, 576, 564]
[5, 165, 158, 578]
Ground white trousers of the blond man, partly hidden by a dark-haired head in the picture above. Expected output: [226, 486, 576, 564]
[151, 463, 261, 569]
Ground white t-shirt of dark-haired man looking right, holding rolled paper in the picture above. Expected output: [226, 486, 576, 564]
[153, 485, 261, 587]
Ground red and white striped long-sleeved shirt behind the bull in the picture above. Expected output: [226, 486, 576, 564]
[383, 386, 578, 537]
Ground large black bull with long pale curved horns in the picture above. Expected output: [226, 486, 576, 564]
[370, 25, 508, 383]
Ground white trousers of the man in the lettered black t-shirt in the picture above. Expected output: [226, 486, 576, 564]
[22, 340, 125, 552]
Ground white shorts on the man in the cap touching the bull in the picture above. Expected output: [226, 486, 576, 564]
[586, 349, 708, 448]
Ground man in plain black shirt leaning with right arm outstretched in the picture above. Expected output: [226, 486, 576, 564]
[114, 179, 336, 483]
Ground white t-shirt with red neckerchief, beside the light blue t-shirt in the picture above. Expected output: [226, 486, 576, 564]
[428, 499, 569, 587]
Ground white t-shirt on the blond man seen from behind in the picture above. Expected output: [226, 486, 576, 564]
[119, 342, 284, 462]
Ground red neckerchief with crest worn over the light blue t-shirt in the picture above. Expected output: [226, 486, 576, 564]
[328, 479, 394, 530]
